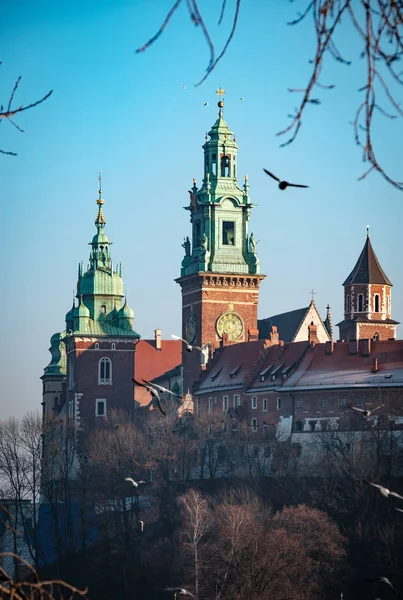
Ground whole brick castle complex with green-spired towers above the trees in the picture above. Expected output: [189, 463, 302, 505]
[42, 98, 403, 446]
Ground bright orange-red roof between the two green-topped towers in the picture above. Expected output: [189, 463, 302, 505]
[134, 340, 182, 406]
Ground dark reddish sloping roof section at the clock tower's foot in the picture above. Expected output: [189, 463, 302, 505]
[195, 340, 266, 395]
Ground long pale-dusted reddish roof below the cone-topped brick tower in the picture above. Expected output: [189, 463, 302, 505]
[282, 340, 403, 391]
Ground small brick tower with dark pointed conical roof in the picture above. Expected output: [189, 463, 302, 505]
[337, 228, 398, 341]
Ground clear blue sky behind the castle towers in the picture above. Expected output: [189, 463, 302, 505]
[0, 0, 403, 418]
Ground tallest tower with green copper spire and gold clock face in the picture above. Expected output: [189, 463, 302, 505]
[176, 89, 265, 390]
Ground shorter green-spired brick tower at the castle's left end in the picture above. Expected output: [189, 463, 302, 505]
[42, 178, 139, 430]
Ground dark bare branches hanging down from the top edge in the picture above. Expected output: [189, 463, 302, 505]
[137, 0, 403, 190]
